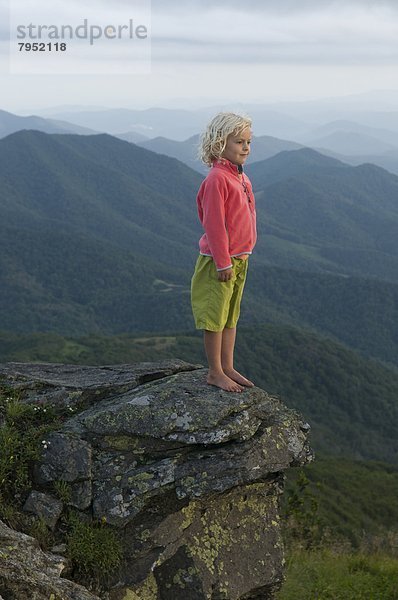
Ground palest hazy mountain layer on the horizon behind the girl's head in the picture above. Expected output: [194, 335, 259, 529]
[38, 99, 398, 144]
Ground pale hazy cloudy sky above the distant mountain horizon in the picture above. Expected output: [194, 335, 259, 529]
[0, 0, 398, 112]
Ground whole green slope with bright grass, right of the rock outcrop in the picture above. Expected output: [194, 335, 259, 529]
[277, 456, 398, 600]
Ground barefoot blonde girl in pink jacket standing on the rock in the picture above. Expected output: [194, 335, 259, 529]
[191, 113, 256, 392]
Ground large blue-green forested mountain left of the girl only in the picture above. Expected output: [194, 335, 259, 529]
[0, 131, 202, 333]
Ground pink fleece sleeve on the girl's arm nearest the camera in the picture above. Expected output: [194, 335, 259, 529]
[198, 171, 232, 271]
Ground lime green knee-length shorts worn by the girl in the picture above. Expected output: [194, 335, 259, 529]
[191, 255, 248, 331]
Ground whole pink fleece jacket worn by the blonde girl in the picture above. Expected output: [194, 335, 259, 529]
[196, 158, 257, 271]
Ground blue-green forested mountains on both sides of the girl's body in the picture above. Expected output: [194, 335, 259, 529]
[0, 131, 398, 362]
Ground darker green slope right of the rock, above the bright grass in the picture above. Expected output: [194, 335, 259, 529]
[283, 454, 398, 553]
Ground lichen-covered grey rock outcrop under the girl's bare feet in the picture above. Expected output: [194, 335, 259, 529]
[0, 360, 312, 600]
